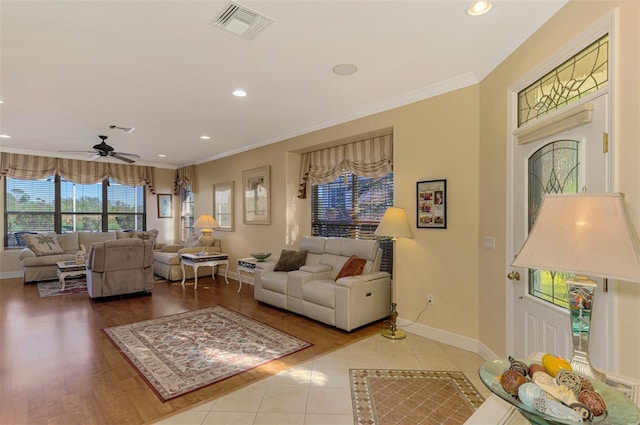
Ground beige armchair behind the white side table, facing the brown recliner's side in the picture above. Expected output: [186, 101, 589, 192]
[153, 235, 222, 282]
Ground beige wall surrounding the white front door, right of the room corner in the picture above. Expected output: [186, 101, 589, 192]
[478, 1, 640, 377]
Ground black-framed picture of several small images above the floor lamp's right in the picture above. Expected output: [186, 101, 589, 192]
[416, 180, 447, 229]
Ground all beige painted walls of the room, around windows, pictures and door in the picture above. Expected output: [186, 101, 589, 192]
[0, 1, 640, 422]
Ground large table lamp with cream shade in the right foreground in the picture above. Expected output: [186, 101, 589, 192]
[511, 193, 640, 381]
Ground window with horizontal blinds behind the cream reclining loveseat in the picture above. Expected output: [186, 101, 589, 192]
[311, 171, 393, 273]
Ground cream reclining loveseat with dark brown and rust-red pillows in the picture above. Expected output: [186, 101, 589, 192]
[254, 237, 391, 331]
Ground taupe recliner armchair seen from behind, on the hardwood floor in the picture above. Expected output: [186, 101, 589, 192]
[87, 238, 153, 298]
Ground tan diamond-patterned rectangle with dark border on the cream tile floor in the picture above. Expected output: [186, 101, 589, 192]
[350, 369, 484, 425]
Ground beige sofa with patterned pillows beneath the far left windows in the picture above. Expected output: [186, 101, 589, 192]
[18, 230, 158, 283]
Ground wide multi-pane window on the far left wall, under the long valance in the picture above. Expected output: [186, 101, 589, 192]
[4, 176, 146, 248]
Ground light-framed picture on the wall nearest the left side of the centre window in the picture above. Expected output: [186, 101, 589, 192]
[242, 165, 271, 224]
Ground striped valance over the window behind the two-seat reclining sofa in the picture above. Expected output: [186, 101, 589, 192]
[298, 134, 393, 199]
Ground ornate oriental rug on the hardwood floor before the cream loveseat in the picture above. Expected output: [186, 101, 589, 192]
[103, 305, 311, 401]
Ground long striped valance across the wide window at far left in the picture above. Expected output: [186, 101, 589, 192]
[0, 152, 156, 194]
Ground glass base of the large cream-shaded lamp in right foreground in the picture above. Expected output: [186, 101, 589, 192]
[567, 276, 606, 382]
